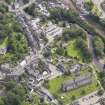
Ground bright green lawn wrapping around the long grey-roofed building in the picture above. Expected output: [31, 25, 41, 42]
[49, 76, 99, 105]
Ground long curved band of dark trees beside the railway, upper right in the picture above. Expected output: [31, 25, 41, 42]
[49, 8, 97, 35]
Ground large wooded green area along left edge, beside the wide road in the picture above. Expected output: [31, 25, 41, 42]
[0, 4, 28, 64]
